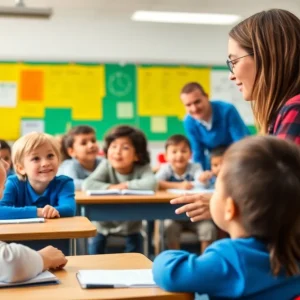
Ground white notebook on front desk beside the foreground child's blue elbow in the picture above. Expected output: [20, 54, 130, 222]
[77, 269, 156, 289]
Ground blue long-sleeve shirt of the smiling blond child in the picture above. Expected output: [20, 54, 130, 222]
[0, 175, 76, 220]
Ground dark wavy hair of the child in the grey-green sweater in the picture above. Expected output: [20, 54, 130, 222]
[103, 125, 150, 166]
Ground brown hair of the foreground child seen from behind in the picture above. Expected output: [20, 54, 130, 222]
[220, 136, 300, 275]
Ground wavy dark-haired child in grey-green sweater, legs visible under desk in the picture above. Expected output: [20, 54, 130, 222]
[83, 126, 156, 254]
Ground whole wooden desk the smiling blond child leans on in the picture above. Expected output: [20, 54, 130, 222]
[0, 217, 97, 255]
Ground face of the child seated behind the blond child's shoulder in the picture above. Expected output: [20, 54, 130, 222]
[68, 133, 99, 162]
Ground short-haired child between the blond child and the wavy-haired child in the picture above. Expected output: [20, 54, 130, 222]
[57, 125, 101, 190]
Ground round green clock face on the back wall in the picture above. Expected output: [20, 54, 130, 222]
[108, 71, 133, 97]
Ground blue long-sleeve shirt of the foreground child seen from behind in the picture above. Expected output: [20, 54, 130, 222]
[153, 238, 300, 300]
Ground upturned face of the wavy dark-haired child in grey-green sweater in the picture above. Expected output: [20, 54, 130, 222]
[107, 137, 138, 174]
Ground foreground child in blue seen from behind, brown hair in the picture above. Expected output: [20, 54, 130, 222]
[153, 136, 300, 300]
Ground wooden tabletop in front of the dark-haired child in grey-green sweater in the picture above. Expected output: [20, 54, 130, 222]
[75, 191, 180, 204]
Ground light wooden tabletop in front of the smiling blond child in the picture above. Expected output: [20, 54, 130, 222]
[0, 217, 97, 241]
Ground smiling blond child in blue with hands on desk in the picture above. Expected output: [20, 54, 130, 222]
[0, 132, 76, 219]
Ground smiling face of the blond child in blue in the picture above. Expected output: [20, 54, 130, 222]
[17, 143, 59, 183]
